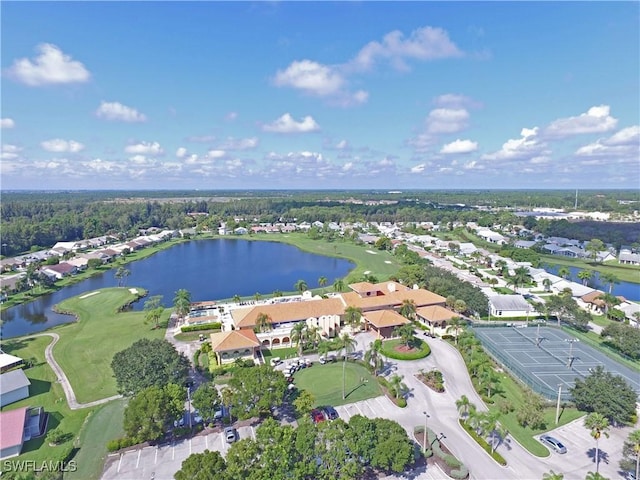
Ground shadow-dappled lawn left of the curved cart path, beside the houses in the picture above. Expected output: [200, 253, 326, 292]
[2, 337, 95, 464]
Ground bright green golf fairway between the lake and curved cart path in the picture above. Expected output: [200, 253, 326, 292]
[53, 288, 169, 403]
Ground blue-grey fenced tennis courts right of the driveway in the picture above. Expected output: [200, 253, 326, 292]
[474, 325, 640, 400]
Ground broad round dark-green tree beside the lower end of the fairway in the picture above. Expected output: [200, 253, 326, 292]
[111, 338, 189, 395]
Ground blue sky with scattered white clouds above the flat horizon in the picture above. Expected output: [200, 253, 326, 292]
[0, 2, 640, 189]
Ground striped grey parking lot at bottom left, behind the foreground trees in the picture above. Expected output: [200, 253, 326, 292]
[102, 426, 255, 480]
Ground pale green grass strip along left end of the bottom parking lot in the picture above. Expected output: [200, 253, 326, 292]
[65, 400, 126, 480]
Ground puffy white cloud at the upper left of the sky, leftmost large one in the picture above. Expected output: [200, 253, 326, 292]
[8, 43, 91, 87]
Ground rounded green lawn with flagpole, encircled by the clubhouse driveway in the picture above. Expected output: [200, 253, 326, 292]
[294, 362, 382, 406]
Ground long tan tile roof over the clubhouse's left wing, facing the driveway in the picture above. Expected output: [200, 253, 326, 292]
[231, 294, 344, 328]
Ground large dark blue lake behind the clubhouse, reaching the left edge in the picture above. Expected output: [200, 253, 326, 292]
[2, 239, 355, 338]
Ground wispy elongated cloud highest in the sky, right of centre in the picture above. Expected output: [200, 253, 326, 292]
[350, 27, 463, 70]
